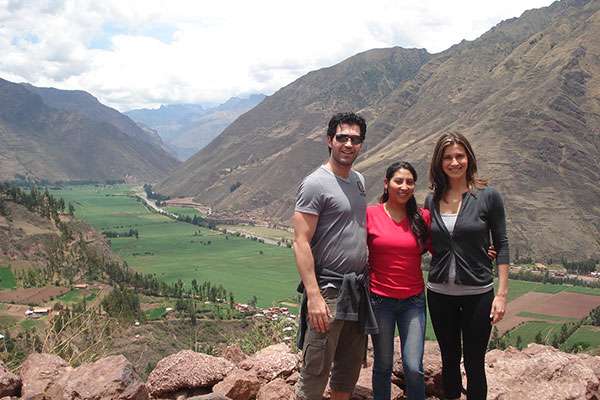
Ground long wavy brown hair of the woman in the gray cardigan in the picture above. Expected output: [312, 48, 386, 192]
[429, 133, 487, 204]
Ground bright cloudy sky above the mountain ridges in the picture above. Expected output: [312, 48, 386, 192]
[0, 0, 552, 111]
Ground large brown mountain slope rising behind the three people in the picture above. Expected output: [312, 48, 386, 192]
[156, 0, 600, 260]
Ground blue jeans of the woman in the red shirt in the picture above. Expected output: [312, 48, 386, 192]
[371, 293, 426, 400]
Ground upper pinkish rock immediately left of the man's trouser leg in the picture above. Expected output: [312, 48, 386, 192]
[239, 343, 299, 381]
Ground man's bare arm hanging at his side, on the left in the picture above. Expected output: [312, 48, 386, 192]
[292, 211, 331, 332]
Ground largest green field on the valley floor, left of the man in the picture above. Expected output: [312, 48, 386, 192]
[52, 185, 298, 306]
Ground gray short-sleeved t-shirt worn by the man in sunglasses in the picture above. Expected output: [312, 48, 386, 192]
[295, 165, 368, 275]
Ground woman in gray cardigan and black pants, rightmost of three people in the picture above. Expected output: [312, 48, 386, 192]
[425, 133, 509, 400]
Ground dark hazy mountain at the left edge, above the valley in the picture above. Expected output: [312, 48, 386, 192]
[0, 79, 178, 181]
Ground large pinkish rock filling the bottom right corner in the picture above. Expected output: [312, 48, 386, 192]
[486, 344, 600, 400]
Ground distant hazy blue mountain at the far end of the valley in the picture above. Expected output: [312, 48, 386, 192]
[126, 94, 265, 160]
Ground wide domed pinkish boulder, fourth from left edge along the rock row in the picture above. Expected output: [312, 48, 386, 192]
[147, 350, 234, 397]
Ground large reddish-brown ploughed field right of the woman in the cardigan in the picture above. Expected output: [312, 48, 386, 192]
[497, 292, 600, 334]
